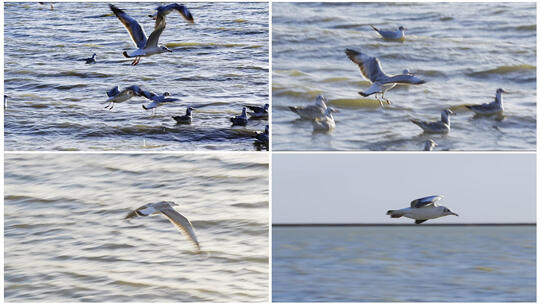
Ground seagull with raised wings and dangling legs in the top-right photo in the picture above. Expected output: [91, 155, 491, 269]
[345, 49, 425, 106]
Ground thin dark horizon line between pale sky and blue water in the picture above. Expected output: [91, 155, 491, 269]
[272, 223, 536, 227]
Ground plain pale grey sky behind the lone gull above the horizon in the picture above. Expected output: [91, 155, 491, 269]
[272, 153, 536, 224]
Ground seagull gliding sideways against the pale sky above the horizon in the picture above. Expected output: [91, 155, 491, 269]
[386, 195, 459, 224]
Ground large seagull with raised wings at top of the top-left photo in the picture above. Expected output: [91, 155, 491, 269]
[109, 4, 172, 65]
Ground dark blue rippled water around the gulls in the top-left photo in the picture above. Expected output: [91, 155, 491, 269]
[4, 2, 268, 151]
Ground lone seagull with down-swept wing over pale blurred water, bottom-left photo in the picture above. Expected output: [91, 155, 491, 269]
[125, 201, 201, 251]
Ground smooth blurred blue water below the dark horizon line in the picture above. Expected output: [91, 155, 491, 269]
[272, 226, 536, 302]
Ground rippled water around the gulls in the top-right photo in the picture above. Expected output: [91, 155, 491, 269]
[272, 2, 536, 150]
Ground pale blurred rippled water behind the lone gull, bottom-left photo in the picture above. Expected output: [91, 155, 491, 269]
[4, 153, 269, 302]
